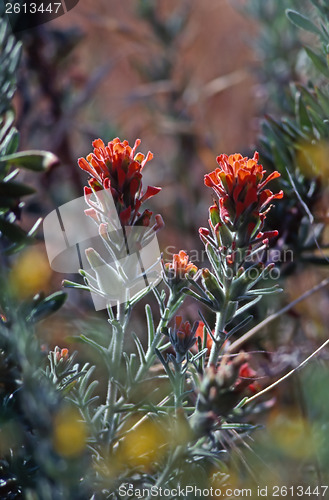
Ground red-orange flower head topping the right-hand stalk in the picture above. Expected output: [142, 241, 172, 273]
[204, 152, 283, 246]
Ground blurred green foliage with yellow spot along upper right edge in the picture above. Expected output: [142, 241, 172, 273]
[252, 1, 329, 272]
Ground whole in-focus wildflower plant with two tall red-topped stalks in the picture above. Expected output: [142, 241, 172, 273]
[46, 138, 283, 491]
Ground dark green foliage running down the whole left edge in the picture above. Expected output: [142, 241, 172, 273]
[0, 13, 88, 500]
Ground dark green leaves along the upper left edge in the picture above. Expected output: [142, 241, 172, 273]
[0, 18, 57, 253]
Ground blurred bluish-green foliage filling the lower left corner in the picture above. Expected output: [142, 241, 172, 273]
[0, 301, 88, 500]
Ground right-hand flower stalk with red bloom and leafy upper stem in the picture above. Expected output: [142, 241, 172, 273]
[187, 153, 283, 365]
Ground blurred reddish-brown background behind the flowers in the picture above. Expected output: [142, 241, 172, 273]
[4, 0, 329, 492]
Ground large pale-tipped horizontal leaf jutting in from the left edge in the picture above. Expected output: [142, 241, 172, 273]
[1, 150, 59, 172]
